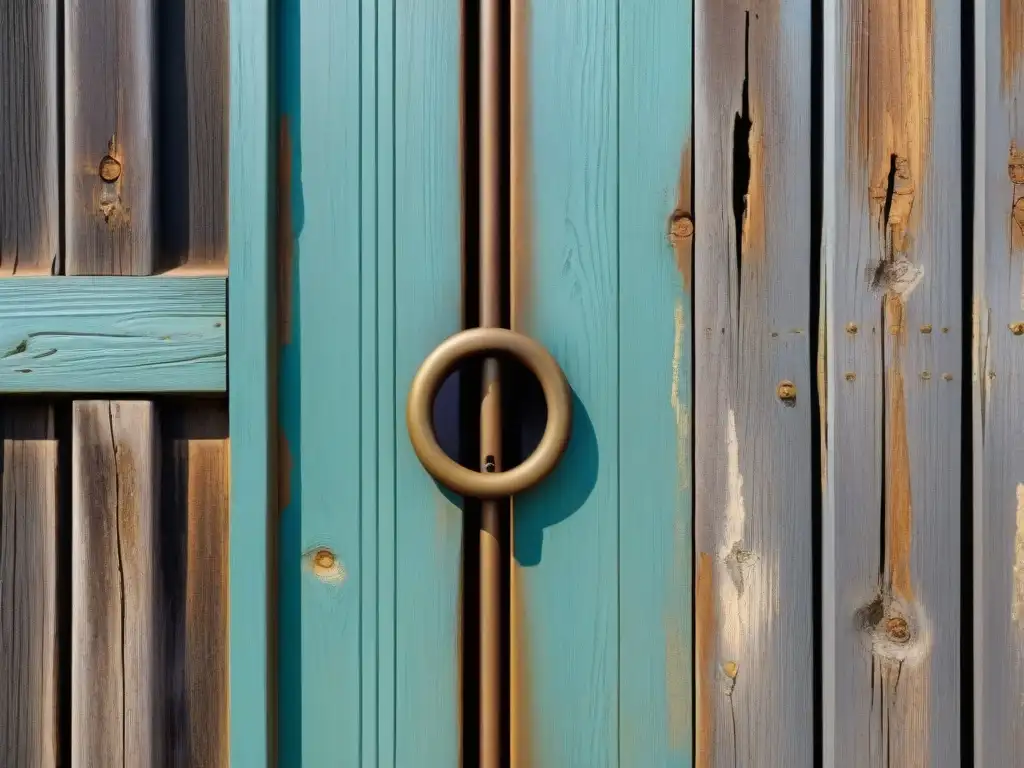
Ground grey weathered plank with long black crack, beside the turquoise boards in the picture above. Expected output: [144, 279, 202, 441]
[693, 0, 819, 766]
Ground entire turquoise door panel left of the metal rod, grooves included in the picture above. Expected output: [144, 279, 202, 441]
[278, 0, 462, 768]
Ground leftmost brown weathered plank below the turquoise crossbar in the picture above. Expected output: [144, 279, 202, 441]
[0, 402, 59, 768]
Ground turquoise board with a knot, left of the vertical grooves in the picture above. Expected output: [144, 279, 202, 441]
[278, 0, 364, 767]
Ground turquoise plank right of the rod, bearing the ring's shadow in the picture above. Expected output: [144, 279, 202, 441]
[512, 0, 614, 768]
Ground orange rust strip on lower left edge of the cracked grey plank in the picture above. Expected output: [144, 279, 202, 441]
[694, 552, 716, 768]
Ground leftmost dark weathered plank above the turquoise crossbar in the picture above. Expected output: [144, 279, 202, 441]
[0, 0, 60, 275]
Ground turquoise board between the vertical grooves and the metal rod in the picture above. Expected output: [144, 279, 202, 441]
[391, 0, 464, 768]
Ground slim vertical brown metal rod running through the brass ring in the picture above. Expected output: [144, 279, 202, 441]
[479, 0, 504, 768]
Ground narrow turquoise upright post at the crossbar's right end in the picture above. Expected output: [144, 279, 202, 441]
[228, 0, 276, 768]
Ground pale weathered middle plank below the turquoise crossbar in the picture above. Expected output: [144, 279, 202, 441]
[71, 400, 159, 765]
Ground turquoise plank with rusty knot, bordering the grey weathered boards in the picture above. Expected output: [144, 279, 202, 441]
[618, 0, 693, 768]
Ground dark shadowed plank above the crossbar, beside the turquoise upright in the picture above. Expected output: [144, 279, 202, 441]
[157, 0, 228, 267]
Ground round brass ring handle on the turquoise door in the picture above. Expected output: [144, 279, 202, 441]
[406, 328, 572, 499]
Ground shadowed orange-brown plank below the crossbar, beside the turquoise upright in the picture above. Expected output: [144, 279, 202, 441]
[158, 399, 230, 768]
